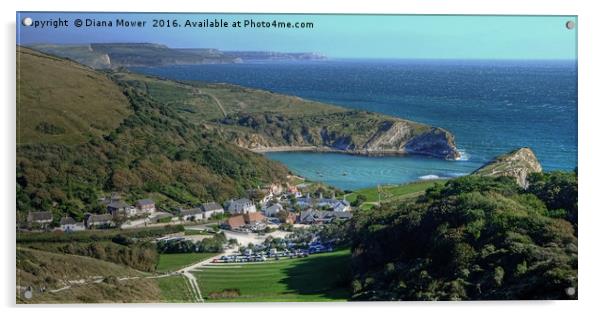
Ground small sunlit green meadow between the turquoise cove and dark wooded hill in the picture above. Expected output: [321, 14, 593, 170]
[347, 180, 447, 209]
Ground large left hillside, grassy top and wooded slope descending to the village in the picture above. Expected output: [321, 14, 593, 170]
[17, 49, 288, 221]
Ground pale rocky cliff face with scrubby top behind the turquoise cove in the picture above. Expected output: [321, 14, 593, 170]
[220, 111, 460, 159]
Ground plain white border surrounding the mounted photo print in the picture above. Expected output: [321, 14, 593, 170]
[0, 0, 602, 316]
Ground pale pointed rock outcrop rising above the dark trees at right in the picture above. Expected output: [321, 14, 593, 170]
[473, 147, 542, 188]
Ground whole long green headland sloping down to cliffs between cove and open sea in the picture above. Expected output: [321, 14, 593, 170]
[116, 73, 460, 159]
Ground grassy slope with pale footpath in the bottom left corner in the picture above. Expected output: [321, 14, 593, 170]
[16, 248, 161, 304]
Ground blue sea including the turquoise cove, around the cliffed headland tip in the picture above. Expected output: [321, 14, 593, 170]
[133, 60, 577, 190]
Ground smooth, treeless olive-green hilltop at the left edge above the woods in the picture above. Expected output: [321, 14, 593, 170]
[17, 47, 131, 144]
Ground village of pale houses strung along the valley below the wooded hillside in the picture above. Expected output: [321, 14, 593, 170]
[22, 184, 352, 233]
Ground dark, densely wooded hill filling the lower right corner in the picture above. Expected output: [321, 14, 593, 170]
[351, 172, 578, 301]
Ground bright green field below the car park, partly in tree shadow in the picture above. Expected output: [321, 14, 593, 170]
[195, 250, 351, 302]
